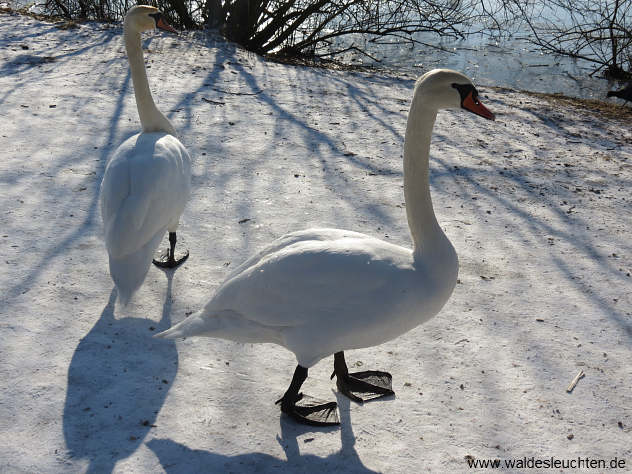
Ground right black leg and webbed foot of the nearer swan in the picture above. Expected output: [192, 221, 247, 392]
[331, 351, 395, 403]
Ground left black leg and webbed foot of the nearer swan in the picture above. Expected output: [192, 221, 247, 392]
[276, 365, 340, 426]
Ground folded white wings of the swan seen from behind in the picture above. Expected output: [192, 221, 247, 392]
[101, 133, 191, 258]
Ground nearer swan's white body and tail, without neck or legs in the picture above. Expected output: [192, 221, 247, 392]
[163, 229, 458, 367]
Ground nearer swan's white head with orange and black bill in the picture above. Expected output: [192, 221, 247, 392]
[413, 69, 495, 120]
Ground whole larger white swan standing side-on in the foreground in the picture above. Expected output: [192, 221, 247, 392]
[157, 69, 494, 424]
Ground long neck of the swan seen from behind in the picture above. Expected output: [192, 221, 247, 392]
[124, 22, 176, 136]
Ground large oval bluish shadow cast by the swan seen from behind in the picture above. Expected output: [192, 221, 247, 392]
[63, 275, 178, 473]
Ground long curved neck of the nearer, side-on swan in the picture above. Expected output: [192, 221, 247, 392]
[404, 100, 453, 260]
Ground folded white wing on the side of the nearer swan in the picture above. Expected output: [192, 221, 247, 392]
[201, 231, 412, 327]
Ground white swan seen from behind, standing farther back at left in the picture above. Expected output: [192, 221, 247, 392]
[101, 5, 191, 304]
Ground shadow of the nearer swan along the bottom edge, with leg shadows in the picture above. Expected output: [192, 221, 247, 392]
[146, 392, 376, 474]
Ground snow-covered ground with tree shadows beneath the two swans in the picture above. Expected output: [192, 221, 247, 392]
[0, 14, 632, 473]
